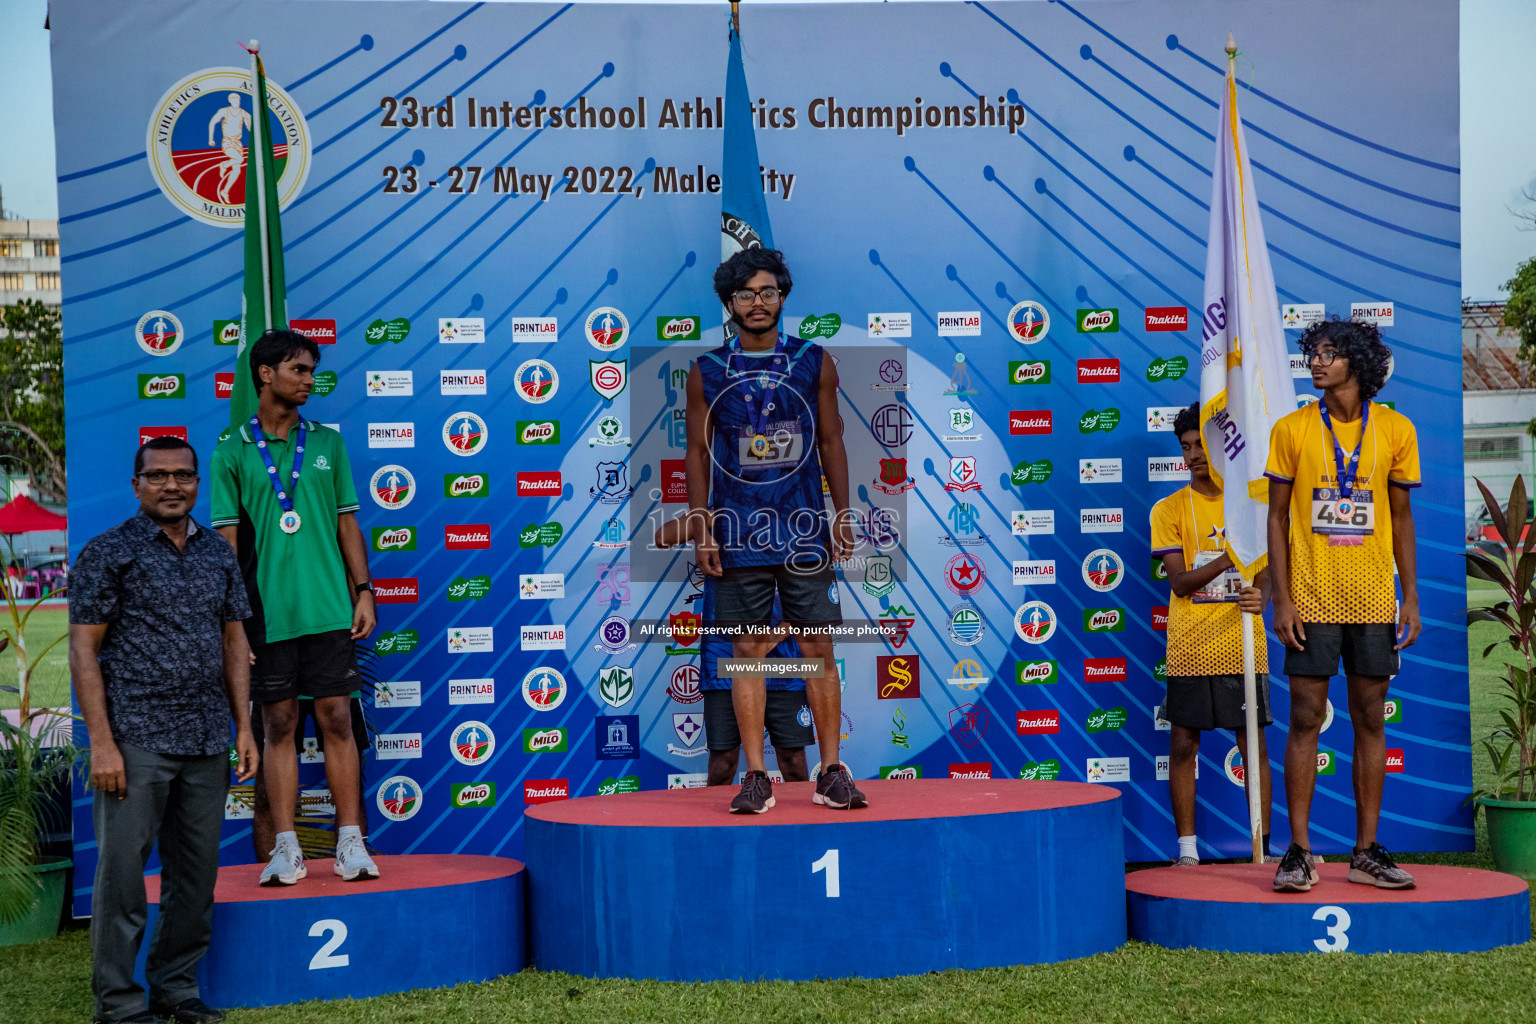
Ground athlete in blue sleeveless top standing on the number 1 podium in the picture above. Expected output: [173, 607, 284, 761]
[687, 249, 868, 814]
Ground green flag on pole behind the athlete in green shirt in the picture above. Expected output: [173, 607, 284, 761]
[229, 40, 287, 430]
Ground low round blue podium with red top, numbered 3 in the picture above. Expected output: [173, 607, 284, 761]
[1126, 863, 1531, 953]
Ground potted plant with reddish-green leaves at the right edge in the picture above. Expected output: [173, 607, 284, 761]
[1467, 476, 1536, 880]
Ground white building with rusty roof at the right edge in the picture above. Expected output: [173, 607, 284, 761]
[1461, 301, 1536, 536]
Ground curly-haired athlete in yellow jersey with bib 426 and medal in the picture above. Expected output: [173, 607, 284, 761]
[1266, 319, 1419, 892]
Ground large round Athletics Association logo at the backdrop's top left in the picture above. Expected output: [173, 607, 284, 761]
[144, 68, 312, 227]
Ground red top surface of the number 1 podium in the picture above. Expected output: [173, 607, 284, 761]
[527, 778, 1120, 827]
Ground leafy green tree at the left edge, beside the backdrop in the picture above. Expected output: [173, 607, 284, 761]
[0, 299, 69, 502]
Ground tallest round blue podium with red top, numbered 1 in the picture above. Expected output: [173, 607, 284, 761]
[525, 778, 1126, 981]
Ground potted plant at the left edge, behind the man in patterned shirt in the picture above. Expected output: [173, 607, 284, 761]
[0, 568, 81, 946]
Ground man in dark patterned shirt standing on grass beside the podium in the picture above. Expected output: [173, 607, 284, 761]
[69, 438, 257, 1024]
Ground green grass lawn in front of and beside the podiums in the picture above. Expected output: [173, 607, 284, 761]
[0, 591, 1536, 1024]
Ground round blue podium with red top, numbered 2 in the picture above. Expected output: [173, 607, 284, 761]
[137, 855, 528, 1007]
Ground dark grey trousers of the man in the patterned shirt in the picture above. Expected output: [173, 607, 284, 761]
[91, 743, 229, 1021]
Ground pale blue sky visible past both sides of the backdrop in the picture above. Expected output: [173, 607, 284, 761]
[0, 0, 1536, 299]
